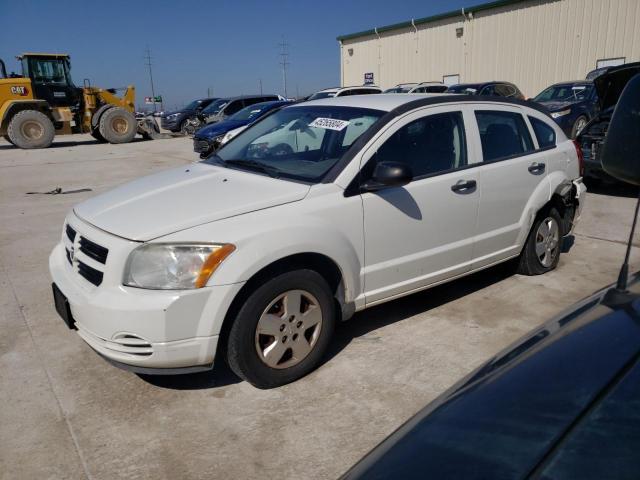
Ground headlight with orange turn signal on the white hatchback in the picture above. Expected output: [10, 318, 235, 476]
[123, 243, 236, 290]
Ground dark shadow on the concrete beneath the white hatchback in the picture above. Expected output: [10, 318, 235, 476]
[138, 262, 516, 390]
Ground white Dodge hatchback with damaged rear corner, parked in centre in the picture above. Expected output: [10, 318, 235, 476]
[49, 95, 586, 388]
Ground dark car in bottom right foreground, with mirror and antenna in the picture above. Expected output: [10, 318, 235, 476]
[343, 75, 640, 480]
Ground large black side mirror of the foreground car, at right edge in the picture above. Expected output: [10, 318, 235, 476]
[600, 74, 640, 185]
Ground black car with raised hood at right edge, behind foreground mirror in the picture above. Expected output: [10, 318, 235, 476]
[576, 62, 640, 180]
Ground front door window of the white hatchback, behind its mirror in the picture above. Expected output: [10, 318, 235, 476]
[376, 112, 467, 177]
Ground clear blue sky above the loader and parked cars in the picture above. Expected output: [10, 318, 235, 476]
[0, 0, 468, 108]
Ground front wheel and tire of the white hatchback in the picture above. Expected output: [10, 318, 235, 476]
[226, 270, 335, 388]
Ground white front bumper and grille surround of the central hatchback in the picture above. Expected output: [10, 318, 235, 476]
[49, 215, 242, 374]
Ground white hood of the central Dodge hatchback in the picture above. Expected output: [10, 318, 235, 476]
[74, 163, 310, 241]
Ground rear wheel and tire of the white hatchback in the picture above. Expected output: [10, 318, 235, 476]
[517, 208, 562, 275]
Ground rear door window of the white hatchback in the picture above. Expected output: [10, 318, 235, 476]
[476, 110, 533, 162]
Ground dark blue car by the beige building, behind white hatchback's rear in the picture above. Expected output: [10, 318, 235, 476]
[533, 80, 599, 138]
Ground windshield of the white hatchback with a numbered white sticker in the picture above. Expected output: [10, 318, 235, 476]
[204, 106, 385, 183]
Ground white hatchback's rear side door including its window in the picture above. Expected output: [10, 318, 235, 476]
[473, 104, 552, 269]
